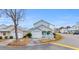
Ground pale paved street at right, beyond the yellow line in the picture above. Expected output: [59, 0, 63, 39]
[57, 34, 79, 48]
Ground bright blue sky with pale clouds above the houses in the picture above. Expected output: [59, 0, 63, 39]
[0, 9, 79, 28]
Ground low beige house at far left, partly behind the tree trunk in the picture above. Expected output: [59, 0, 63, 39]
[0, 25, 26, 39]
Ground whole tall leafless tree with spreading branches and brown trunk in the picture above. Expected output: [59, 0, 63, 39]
[2, 9, 23, 41]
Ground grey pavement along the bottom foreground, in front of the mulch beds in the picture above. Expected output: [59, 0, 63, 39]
[0, 39, 71, 50]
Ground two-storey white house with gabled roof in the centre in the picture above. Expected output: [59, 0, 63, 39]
[28, 20, 55, 40]
